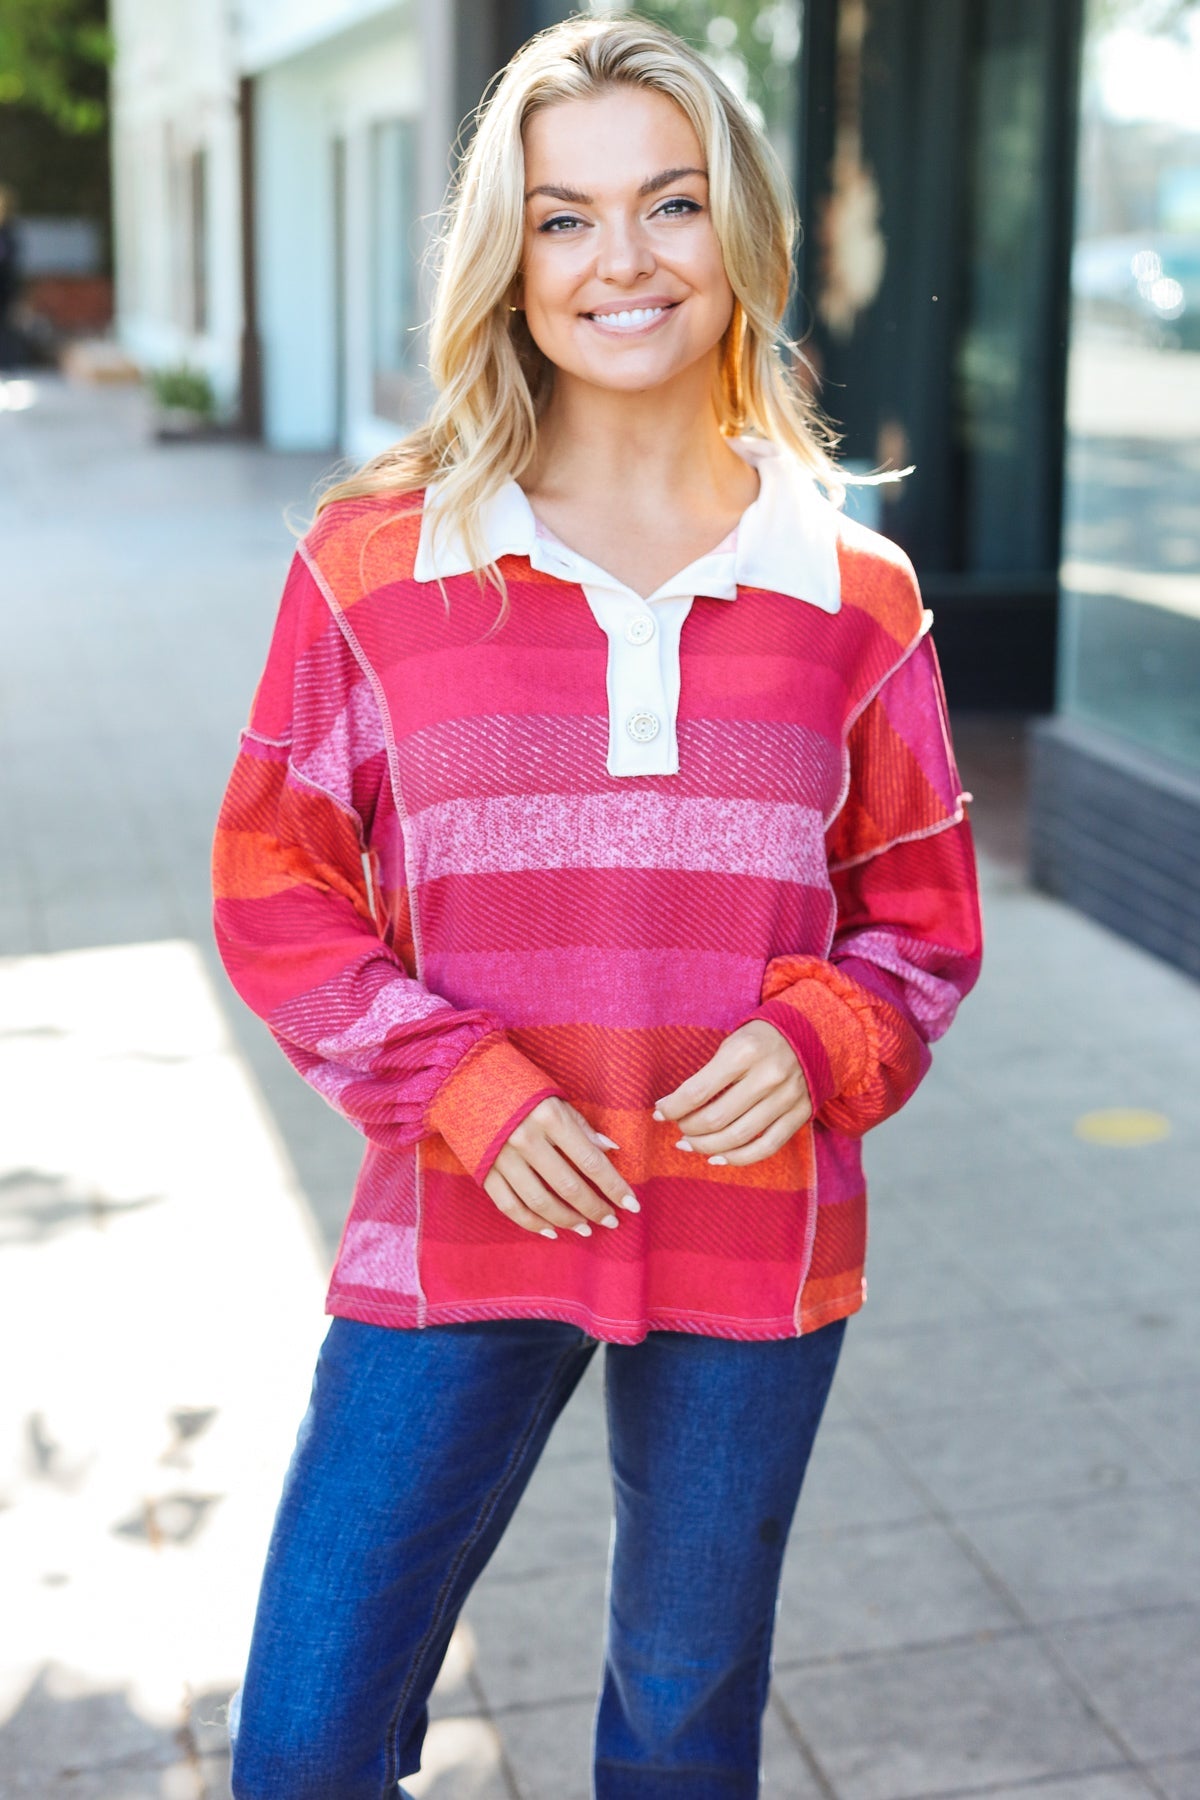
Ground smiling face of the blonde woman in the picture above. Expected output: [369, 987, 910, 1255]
[516, 86, 734, 403]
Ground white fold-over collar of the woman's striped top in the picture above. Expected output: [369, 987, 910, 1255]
[412, 437, 842, 612]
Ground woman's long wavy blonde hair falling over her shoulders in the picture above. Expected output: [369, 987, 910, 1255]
[317, 14, 846, 626]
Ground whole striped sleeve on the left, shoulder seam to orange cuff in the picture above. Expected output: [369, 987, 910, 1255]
[214, 553, 561, 1181]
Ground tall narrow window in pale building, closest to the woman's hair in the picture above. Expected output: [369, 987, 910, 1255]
[371, 119, 419, 423]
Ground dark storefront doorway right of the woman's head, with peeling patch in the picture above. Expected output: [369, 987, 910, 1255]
[797, 0, 1081, 711]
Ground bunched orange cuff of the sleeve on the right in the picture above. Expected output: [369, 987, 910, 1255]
[737, 956, 880, 1116]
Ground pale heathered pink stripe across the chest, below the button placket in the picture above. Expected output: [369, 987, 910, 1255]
[410, 794, 829, 887]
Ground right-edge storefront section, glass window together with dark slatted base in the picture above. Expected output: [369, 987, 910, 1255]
[1031, 0, 1200, 976]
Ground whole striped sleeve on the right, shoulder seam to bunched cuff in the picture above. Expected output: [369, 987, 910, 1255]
[752, 619, 982, 1136]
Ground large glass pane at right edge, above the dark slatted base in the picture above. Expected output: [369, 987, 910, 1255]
[1061, 0, 1200, 769]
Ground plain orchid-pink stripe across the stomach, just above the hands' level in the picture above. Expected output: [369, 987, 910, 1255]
[428, 947, 763, 1031]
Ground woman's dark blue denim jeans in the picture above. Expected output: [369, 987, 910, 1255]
[230, 1319, 846, 1800]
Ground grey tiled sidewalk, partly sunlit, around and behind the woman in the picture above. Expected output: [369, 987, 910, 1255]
[0, 380, 1200, 1800]
